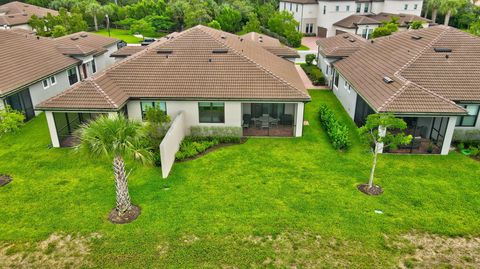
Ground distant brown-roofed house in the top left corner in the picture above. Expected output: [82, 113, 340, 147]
[0, 1, 58, 30]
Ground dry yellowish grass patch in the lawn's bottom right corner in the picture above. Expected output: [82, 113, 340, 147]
[399, 233, 480, 268]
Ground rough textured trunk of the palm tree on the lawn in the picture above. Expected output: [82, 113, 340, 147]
[113, 155, 132, 215]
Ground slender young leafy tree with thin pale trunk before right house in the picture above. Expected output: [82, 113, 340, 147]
[358, 113, 412, 194]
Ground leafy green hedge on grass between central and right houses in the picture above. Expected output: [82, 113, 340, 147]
[320, 105, 350, 149]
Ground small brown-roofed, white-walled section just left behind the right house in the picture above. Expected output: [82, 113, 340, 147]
[317, 33, 368, 87]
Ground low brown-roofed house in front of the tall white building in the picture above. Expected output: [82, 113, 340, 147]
[333, 12, 431, 39]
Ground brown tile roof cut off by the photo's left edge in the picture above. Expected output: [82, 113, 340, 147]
[0, 30, 78, 96]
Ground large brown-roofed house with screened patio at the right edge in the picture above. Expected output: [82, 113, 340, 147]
[320, 26, 480, 154]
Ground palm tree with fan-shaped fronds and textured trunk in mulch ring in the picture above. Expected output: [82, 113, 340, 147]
[77, 116, 151, 223]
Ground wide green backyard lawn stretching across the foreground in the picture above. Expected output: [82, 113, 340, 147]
[0, 91, 480, 268]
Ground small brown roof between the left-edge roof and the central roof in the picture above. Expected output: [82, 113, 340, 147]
[54, 32, 120, 55]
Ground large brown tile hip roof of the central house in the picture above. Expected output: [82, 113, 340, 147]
[37, 26, 310, 109]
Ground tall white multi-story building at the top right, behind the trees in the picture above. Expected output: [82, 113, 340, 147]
[279, 0, 423, 37]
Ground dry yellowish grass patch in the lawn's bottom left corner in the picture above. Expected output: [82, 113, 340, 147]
[0, 233, 101, 268]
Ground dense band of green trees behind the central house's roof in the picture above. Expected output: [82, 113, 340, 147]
[27, 0, 302, 47]
